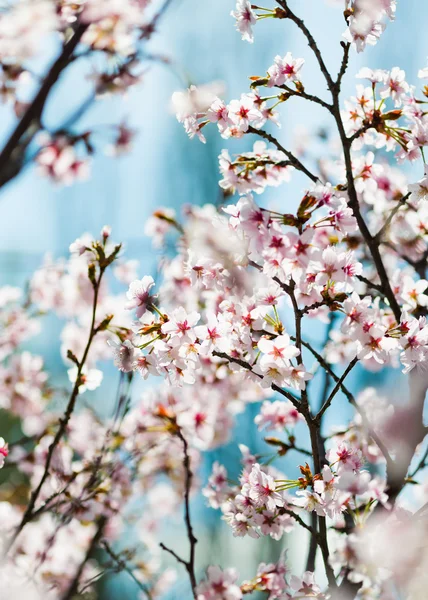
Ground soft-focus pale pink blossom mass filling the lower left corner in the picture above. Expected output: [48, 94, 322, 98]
[0, 227, 187, 600]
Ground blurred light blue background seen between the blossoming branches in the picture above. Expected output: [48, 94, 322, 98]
[0, 0, 428, 600]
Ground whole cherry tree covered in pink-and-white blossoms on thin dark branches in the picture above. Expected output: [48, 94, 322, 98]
[0, 0, 428, 600]
